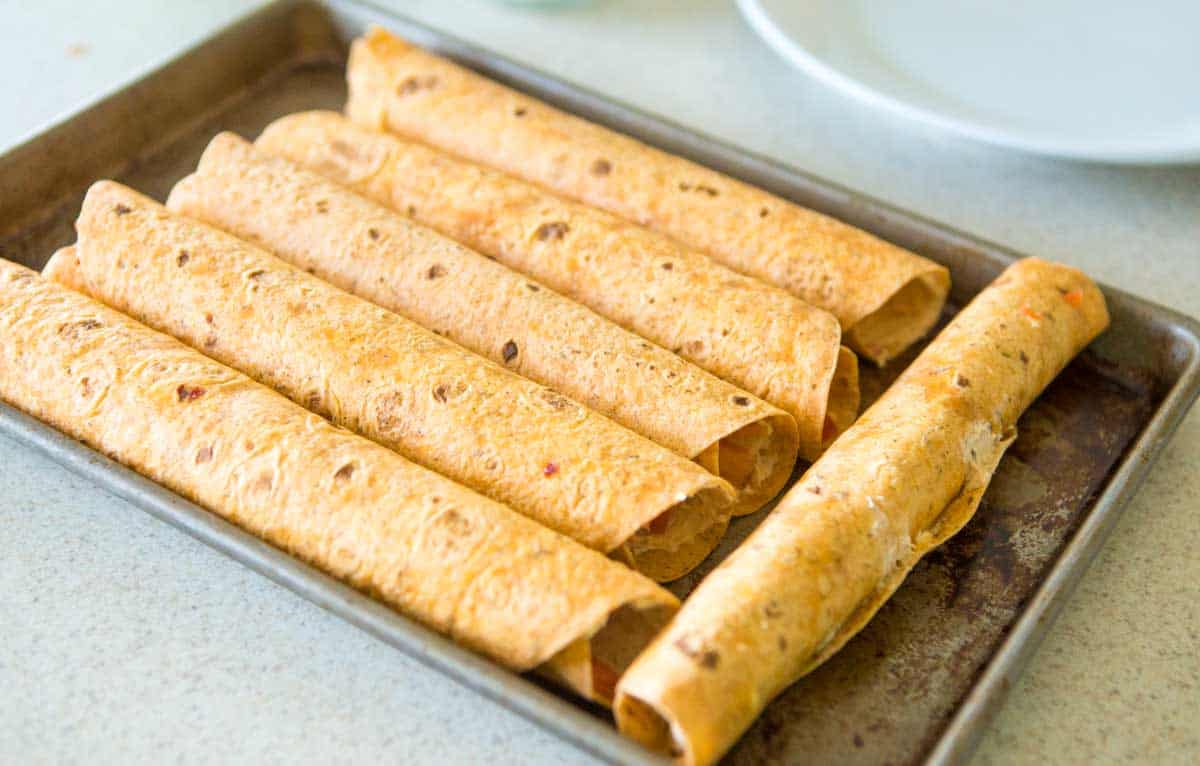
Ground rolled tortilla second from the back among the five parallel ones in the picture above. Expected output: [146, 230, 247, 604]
[257, 112, 858, 461]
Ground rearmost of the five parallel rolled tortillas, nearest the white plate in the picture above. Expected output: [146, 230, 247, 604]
[346, 28, 950, 365]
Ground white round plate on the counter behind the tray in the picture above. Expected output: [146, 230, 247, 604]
[738, 0, 1200, 163]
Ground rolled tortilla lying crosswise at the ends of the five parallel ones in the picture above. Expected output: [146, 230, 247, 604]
[616, 259, 1108, 765]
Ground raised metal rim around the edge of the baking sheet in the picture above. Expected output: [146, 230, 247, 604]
[0, 0, 1200, 765]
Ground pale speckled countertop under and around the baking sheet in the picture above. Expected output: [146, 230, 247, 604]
[0, 0, 1200, 766]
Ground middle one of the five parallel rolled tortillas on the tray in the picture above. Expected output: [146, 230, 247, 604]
[167, 133, 797, 514]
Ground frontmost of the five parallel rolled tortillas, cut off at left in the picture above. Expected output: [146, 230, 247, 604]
[0, 261, 678, 701]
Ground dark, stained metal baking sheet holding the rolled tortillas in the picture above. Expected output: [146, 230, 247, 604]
[0, 1, 1200, 764]
